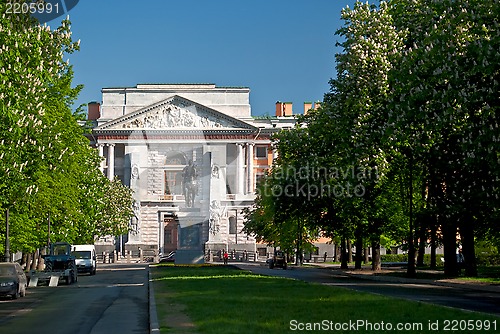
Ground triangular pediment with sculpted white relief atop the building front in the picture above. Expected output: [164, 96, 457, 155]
[96, 95, 256, 131]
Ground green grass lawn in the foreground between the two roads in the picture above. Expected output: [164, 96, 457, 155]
[151, 265, 500, 334]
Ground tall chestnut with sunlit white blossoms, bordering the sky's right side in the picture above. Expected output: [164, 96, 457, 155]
[325, 1, 403, 270]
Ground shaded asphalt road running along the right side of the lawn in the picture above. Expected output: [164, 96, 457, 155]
[237, 264, 500, 316]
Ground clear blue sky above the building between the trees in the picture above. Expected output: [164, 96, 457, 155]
[48, 0, 355, 115]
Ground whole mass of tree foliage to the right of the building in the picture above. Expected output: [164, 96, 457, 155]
[245, 0, 500, 274]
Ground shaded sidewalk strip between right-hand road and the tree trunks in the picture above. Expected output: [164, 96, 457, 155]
[307, 263, 500, 293]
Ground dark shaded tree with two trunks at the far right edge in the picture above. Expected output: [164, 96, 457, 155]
[391, 0, 500, 275]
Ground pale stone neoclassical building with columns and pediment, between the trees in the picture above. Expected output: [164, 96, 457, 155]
[88, 84, 312, 262]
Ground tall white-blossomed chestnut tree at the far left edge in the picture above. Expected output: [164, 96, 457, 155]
[0, 4, 80, 250]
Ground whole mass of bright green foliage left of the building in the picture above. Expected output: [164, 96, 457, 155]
[0, 3, 132, 252]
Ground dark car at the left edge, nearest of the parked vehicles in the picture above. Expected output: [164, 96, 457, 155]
[0, 262, 28, 299]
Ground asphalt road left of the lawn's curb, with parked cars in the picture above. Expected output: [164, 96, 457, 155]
[0, 264, 149, 334]
